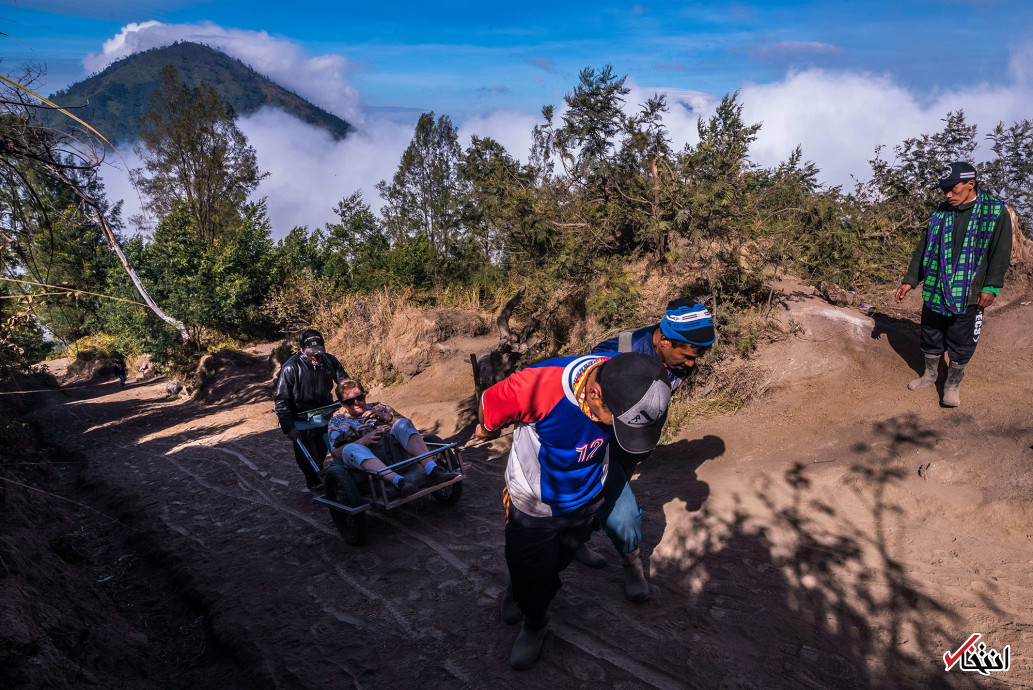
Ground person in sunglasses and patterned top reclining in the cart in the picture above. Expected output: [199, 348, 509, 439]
[327, 379, 456, 497]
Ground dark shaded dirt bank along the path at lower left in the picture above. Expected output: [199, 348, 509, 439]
[0, 388, 250, 688]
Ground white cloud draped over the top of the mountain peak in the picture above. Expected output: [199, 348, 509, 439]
[83, 21, 364, 126]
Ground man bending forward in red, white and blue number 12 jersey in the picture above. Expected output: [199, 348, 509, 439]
[475, 353, 670, 669]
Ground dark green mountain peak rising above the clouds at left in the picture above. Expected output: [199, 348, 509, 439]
[51, 41, 354, 144]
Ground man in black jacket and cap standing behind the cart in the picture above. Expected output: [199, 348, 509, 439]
[274, 328, 349, 489]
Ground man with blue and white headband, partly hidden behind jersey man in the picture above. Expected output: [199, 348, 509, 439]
[574, 300, 717, 601]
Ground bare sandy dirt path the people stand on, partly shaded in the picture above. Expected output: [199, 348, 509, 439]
[16, 276, 1033, 688]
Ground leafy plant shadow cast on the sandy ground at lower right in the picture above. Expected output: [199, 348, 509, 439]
[653, 417, 966, 688]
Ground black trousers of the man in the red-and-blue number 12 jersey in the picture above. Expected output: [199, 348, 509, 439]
[506, 495, 601, 628]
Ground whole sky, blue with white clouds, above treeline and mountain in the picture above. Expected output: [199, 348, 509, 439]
[0, 0, 1033, 234]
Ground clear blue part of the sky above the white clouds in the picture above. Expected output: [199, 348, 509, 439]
[8, 0, 1033, 114]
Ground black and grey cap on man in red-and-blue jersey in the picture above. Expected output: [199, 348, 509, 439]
[598, 352, 670, 452]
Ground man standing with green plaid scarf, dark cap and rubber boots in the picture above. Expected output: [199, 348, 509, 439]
[894, 162, 1011, 407]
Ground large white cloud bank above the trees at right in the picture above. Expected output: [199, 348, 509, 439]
[628, 35, 1033, 188]
